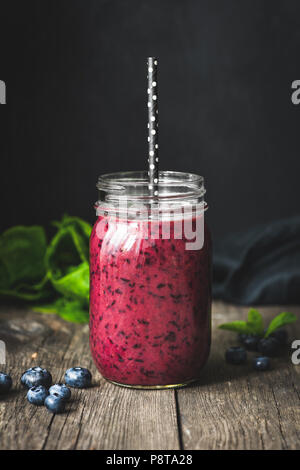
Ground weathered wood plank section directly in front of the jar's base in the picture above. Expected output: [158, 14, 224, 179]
[45, 381, 179, 450]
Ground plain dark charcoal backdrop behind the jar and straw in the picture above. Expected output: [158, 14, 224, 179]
[0, 0, 300, 239]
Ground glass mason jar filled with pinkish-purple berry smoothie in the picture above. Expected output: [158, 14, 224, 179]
[90, 171, 211, 388]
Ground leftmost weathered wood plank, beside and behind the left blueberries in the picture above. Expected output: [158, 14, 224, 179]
[0, 309, 78, 450]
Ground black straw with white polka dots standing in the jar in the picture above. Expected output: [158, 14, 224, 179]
[147, 57, 158, 196]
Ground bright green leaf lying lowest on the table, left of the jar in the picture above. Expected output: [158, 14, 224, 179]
[33, 298, 89, 323]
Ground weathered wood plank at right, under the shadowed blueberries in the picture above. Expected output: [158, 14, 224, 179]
[176, 303, 300, 449]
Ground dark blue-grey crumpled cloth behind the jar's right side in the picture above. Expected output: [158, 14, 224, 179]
[213, 216, 300, 305]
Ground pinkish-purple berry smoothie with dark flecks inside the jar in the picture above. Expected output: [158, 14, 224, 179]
[90, 216, 211, 387]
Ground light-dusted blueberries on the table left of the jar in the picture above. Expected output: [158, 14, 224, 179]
[0, 367, 92, 414]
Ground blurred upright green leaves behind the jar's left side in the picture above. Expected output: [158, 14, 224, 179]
[0, 215, 92, 303]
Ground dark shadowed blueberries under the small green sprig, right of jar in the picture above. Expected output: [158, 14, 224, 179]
[225, 329, 288, 371]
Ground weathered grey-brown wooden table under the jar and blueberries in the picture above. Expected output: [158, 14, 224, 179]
[0, 303, 300, 450]
